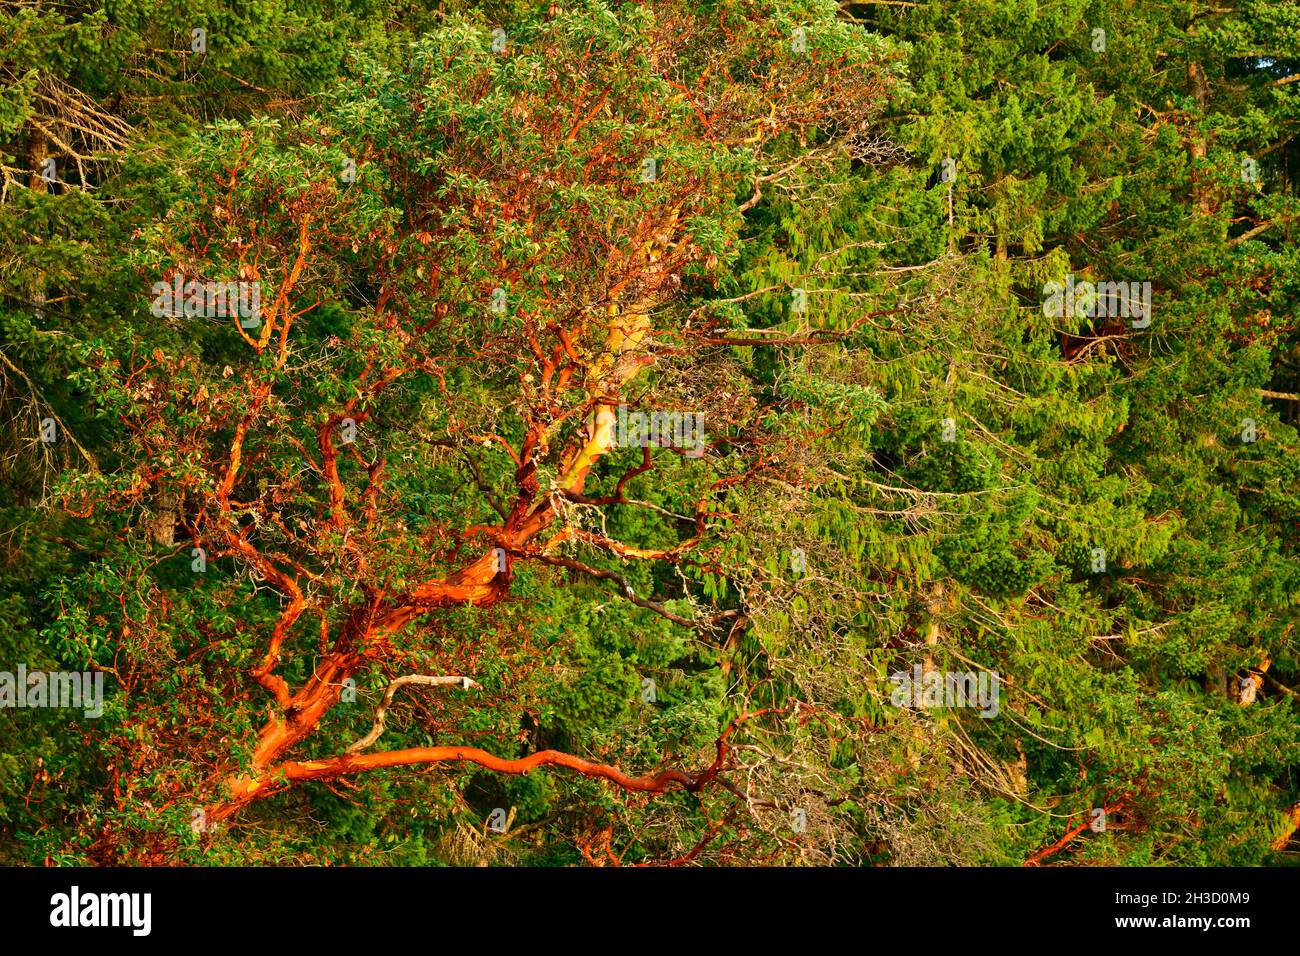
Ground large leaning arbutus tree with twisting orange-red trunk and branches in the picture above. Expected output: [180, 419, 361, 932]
[60, 0, 896, 858]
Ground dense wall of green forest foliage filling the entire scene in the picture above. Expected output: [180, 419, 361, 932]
[0, 0, 1300, 865]
